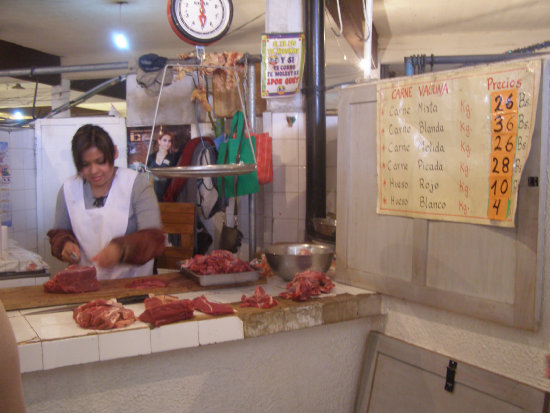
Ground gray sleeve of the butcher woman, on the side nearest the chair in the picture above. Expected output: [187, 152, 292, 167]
[130, 174, 162, 230]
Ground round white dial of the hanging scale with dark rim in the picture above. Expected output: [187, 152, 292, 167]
[167, 0, 233, 45]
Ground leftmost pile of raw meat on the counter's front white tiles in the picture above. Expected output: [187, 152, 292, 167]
[73, 298, 136, 330]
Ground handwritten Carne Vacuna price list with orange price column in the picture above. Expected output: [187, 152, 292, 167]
[377, 59, 541, 227]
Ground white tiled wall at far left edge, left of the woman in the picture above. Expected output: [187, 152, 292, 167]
[0, 129, 37, 252]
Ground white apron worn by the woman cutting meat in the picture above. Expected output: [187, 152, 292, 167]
[63, 168, 153, 280]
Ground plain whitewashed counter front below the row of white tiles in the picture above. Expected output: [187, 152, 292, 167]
[23, 317, 381, 413]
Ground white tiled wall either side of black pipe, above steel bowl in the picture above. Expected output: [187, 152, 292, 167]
[263, 112, 338, 245]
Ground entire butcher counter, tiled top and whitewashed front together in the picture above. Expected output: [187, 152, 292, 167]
[4, 273, 385, 413]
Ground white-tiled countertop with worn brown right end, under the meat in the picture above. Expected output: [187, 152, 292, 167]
[8, 277, 380, 373]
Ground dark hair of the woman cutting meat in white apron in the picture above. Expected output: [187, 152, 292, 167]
[71, 124, 115, 172]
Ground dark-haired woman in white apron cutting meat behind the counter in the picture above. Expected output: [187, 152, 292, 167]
[48, 124, 164, 280]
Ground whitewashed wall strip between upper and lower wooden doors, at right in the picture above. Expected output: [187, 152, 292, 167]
[382, 154, 550, 391]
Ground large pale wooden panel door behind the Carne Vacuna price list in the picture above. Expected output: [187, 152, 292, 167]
[336, 61, 549, 330]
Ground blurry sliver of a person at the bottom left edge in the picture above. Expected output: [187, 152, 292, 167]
[0, 301, 26, 413]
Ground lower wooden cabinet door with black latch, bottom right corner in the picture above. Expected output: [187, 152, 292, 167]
[356, 332, 547, 413]
